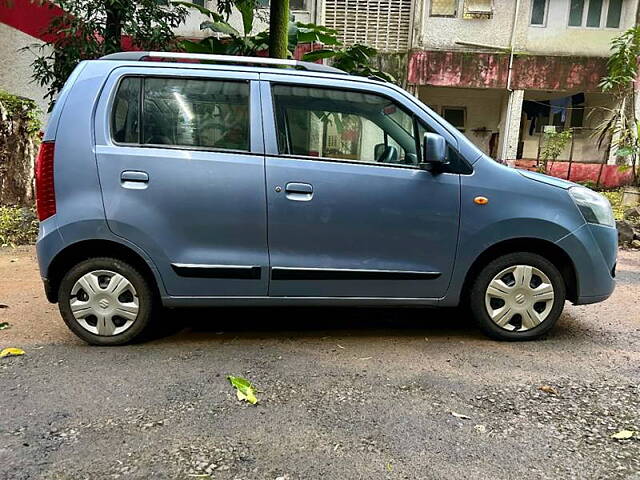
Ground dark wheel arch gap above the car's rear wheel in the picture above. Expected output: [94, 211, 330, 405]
[47, 240, 160, 303]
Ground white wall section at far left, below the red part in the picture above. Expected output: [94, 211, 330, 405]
[0, 23, 48, 112]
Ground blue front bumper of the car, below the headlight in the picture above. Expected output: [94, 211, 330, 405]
[556, 223, 618, 305]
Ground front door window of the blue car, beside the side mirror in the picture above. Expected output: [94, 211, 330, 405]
[273, 85, 418, 166]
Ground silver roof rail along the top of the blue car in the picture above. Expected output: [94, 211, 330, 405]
[100, 52, 347, 75]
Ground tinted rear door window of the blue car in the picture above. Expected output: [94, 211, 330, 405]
[112, 77, 249, 151]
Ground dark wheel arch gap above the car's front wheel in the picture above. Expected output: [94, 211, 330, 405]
[462, 237, 578, 303]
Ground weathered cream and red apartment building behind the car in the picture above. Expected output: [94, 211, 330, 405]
[0, 0, 639, 172]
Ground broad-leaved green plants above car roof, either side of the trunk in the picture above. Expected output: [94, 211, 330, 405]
[173, 0, 395, 82]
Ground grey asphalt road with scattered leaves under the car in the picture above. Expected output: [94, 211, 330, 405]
[0, 248, 640, 480]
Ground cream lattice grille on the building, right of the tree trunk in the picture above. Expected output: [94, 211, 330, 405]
[325, 0, 412, 52]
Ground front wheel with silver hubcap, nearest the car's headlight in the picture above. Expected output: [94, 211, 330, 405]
[469, 252, 566, 341]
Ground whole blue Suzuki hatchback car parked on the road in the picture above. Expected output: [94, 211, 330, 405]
[36, 52, 617, 345]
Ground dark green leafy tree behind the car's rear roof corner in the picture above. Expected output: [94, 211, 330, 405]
[27, 0, 187, 108]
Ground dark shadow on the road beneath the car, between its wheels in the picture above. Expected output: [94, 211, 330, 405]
[151, 307, 483, 341]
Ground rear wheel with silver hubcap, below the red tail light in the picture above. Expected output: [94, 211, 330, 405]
[58, 257, 156, 346]
